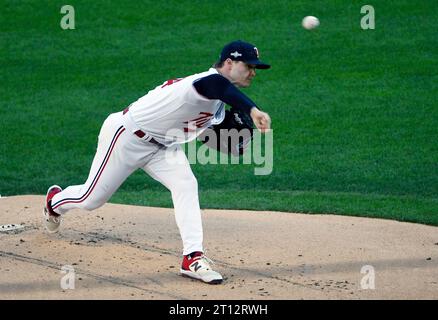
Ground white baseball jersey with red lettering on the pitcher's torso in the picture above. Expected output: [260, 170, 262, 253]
[129, 68, 225, 146]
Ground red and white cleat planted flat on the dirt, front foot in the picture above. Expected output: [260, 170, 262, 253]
[180, 251, 223, 284]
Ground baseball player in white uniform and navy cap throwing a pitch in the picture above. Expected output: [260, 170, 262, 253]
[43, 41, 271, 284]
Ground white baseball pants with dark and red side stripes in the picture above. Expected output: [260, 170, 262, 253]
[52, 112, 203, 255]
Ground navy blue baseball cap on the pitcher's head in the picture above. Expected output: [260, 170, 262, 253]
[220, 40, 271, 69]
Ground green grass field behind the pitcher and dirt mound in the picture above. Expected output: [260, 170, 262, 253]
[0, 0, 438, 225]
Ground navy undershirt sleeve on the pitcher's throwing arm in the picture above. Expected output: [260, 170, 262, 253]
[193, 74, 256, 114]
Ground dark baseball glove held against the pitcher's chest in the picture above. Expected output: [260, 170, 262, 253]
[199, 108, 254, 156]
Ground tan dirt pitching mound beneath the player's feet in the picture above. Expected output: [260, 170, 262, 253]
[0, 196, 438, 300]
